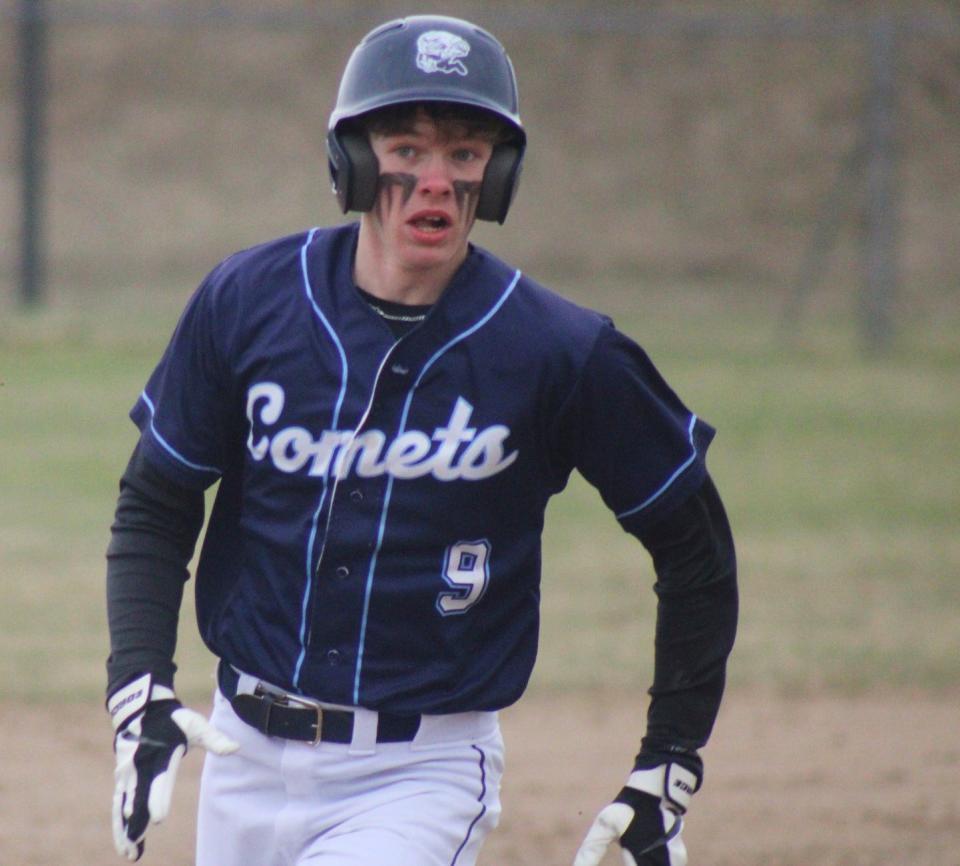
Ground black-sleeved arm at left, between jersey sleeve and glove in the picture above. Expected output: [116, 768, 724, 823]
[107, 451, 203, 693]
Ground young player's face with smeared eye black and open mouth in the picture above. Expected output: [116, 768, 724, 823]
[365, 112, 493, 270]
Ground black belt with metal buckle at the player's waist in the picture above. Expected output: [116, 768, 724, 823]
[217, 661, 420, 743]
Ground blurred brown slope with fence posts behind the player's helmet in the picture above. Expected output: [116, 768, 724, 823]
[0, 0, 960, 348]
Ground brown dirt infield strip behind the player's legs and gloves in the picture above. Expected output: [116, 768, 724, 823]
[0, 693, 960, 866]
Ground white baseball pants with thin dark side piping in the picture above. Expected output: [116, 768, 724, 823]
[197, 691, 503, 866]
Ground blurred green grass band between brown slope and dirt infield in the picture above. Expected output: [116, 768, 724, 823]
[0, 293, 960, 700]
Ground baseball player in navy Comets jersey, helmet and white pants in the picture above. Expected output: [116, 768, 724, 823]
[107, 16, 737, 866]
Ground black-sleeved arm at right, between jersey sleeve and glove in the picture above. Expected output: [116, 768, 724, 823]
[642, 477, 738, 764]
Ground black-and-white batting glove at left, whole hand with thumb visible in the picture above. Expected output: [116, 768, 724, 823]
[107, 674, 239, 860]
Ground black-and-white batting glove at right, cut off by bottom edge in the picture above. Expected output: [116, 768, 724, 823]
[573, 763, 700, 866]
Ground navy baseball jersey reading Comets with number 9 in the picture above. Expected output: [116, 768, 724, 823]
[131, 224, 713, 713]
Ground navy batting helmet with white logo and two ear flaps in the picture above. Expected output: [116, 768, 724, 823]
[327, 15, 526, 223]
